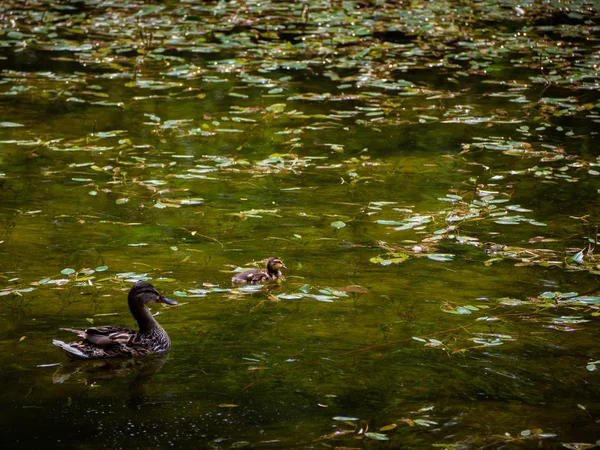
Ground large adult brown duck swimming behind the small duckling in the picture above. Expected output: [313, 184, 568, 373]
[52, 281, 177, 359]
